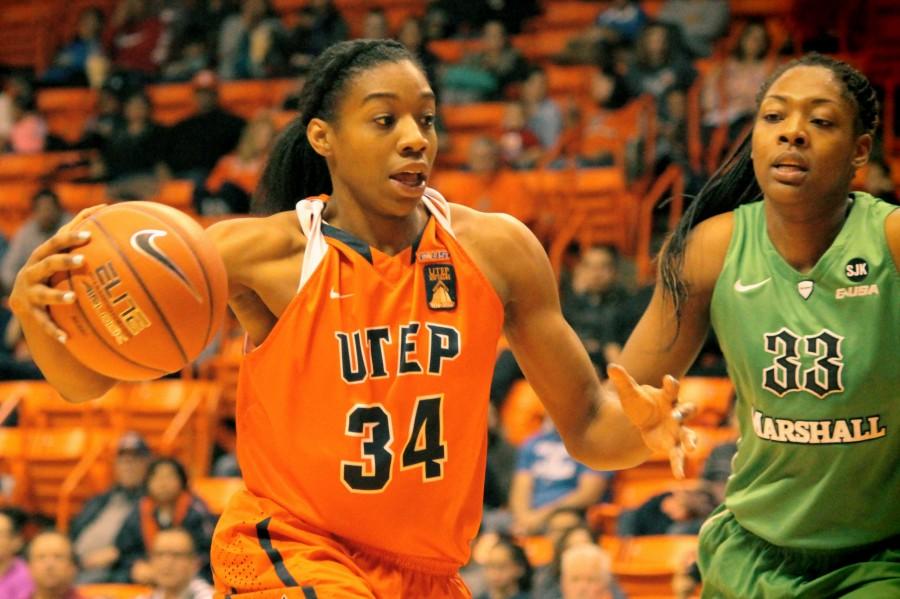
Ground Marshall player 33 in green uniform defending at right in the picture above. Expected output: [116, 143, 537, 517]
[610, 54, 900, 599]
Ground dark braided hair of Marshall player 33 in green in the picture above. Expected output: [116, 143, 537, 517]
[659, 52, 879, 336]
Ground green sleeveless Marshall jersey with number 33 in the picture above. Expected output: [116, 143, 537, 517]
[710, 193, 900, 550]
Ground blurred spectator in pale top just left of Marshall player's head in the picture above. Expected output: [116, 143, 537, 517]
[701, 21, 774, 140]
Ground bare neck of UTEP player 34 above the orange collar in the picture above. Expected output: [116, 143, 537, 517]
[324, 198, 428, 256]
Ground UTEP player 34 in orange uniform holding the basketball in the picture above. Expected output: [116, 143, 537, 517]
[8, 40, 689, 599]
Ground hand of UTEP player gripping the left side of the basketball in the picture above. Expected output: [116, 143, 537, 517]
[9, 204, 105, 343]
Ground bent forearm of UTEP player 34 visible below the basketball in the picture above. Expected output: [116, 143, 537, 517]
[16, 314, 116, 403]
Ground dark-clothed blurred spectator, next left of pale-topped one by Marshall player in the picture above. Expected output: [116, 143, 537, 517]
[625, 23, 696, 110]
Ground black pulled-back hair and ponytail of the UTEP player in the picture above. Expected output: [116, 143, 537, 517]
[253, 39, 422, 214]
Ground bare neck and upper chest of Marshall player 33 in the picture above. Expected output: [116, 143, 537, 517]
[764, 194, 850, 272]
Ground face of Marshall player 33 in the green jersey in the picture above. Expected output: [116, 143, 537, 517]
[752, 66, 872, 209]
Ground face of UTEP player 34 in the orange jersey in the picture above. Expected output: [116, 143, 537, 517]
[325, 60, 437, 217]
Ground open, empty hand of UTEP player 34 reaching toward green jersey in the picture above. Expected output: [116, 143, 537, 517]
[607, 364, 697, 479]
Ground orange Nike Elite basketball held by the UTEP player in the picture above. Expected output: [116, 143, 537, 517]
[50, 202, 228, 381]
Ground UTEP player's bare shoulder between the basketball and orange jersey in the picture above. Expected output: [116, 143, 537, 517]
[207, 211, 306, 284]
